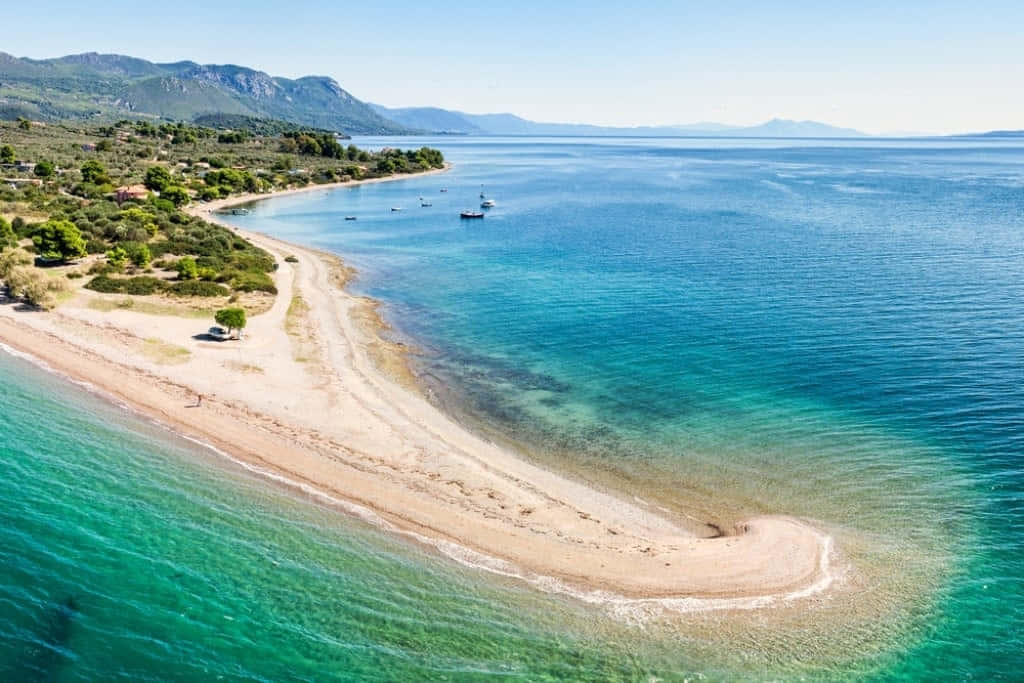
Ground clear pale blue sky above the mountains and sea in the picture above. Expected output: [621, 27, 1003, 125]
[0, 0, 1024, 133]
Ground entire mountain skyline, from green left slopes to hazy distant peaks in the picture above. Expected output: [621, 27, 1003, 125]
[6, 52, 1007, 137]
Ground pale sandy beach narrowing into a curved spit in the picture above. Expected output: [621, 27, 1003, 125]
[0, 171, 833, 608]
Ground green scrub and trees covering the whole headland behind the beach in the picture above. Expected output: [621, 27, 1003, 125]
[0, 119, 444, 303]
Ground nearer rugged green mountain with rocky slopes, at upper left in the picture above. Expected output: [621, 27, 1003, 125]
[0, 52, 410, 134]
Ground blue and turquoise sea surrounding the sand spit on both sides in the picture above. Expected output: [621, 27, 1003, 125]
[0, 138, 1024, 681]
